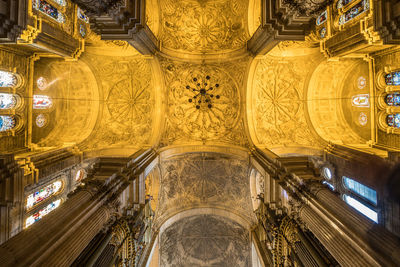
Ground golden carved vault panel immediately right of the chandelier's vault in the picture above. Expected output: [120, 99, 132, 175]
[252, 56, 324, 146]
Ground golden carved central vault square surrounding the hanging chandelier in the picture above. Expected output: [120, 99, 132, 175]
[162, 60, 246, 145]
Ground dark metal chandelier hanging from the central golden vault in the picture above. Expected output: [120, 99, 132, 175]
[186, 75, 220, 109]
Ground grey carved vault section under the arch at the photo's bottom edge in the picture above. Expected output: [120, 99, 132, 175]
[160, 215, 251, 267]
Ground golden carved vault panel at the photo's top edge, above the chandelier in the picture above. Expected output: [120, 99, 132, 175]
[161, 0, 247, 52]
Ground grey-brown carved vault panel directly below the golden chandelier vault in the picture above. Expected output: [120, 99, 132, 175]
[157, 153, 253, 224]
